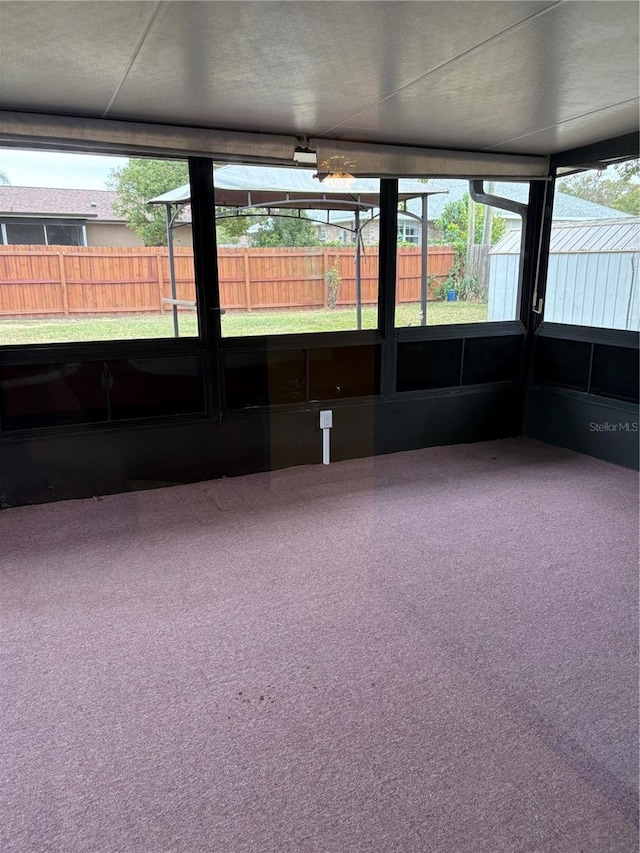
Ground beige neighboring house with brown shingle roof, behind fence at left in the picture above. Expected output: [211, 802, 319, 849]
[0, 186, 192, 247]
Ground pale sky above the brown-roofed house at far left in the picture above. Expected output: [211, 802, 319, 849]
[0, 148, 127, 190]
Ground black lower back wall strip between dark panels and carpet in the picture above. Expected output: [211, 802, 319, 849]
[0, 384, 522, 507]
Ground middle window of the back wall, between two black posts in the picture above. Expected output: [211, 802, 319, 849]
[214, 165, 380, 337]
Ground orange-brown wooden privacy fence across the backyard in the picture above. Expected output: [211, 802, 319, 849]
[0, 246, 454, 317]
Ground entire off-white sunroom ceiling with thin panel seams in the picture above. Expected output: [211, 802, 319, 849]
[0, 0, 639, 154]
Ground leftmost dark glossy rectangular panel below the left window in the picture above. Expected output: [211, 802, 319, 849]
[0, 361, 108, 430]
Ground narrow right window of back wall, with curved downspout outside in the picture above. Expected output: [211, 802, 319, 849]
[395, 179, 529, 327]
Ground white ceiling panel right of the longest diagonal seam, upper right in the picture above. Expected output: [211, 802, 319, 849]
[336, 2, 638, 153]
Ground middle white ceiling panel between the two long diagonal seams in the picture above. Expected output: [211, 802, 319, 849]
[111, 0, 550, 135]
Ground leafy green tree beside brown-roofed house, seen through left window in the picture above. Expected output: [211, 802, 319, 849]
[107, 159, 189, 246]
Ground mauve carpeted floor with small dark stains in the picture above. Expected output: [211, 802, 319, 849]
[0, 440, 638, 853]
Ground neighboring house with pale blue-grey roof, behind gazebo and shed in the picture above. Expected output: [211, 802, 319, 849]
[309, 179, 631, 245]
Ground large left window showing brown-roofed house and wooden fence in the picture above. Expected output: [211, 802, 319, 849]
[0, 149, 198, 345]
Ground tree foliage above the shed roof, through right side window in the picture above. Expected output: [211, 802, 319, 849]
[558, 160, 640, 216]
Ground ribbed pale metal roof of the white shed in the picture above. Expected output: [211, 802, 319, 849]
[489, 216, 640, 255]
